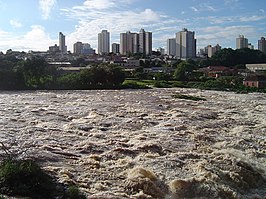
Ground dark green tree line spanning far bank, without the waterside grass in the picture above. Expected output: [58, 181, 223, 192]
[0, 48, 266, 90]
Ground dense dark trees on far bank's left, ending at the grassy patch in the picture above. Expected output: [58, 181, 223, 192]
[0, 56, 125, 90]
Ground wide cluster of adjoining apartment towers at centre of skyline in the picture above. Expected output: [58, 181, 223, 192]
[120, 29, 152, 55]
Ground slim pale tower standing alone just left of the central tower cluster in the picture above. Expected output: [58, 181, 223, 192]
[98, 30, 110, 55]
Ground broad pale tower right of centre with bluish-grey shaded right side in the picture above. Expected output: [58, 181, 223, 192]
[176, 28, 196, 59]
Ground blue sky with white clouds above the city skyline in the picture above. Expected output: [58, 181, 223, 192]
[0, 0, 266, 52]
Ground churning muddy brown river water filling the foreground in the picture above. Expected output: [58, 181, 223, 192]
[0, 88, 266, 199]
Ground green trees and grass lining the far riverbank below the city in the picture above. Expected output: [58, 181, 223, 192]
[0, 48, 266, 92]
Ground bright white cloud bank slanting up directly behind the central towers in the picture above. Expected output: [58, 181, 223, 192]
[67, 9, 160, 49]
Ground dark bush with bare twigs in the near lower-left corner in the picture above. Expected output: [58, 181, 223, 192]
[0, 142, 86, 199]
